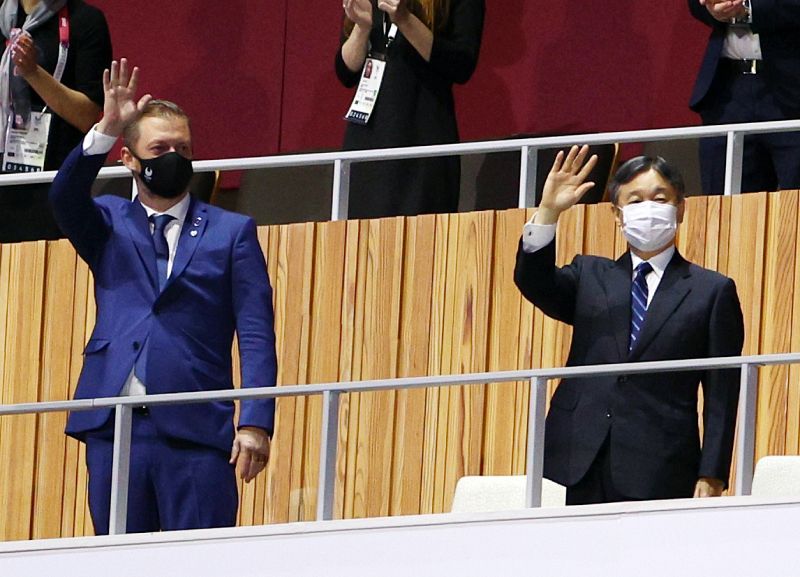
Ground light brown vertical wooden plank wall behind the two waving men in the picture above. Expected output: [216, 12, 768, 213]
[0, 191, 800, 539]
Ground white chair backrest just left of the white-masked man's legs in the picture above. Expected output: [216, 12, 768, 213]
[451, 475, 566, 513]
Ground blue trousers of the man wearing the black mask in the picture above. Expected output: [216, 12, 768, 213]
[86, 414, 239, 535]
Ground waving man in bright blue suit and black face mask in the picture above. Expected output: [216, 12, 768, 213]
[50, 59, 277, 534]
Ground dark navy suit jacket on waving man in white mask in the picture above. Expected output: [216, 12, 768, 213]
[514, 240, 744, 499]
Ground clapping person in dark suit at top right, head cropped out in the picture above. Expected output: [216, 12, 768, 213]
[688, 0, 800, 194]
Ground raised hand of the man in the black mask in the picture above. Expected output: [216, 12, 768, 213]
[97, 58, 153, 136]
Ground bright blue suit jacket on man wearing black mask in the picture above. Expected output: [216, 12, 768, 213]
[50, 145, 277, 451]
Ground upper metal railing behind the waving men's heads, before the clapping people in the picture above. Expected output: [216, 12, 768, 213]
[0, 120, 800, 220]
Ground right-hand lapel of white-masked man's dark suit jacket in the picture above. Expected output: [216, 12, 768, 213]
[628, 250, 692, 361]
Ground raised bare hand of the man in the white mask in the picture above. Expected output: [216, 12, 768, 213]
[536, 145, 597, 224]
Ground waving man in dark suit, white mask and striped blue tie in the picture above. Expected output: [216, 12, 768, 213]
[514, 147, 744, 504]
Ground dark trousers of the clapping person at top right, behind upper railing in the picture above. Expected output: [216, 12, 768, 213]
[700, 59, 800, 194]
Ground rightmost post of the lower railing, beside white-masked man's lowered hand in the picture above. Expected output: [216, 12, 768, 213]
[735, 364, 758, 495]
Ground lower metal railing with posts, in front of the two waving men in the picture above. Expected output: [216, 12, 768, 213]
[0, 353, 800, 535]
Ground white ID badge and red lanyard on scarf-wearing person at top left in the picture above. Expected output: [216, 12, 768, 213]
[2, 6, 69, 172]
